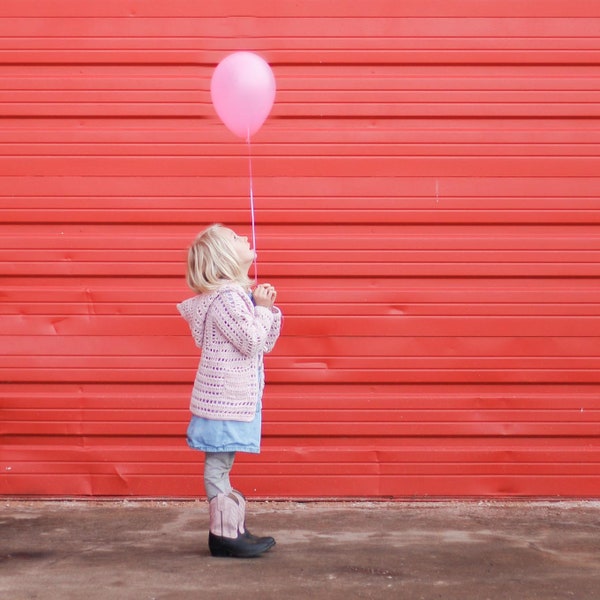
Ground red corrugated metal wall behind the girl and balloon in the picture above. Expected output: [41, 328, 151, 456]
[0, 0, 600, 497]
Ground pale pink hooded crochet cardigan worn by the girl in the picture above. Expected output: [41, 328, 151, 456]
[177, 284, 281, 422]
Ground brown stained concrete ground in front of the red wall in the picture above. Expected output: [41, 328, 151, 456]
[0, 500, 600, 600]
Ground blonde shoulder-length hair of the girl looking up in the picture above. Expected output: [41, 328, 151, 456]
[186, 223, 251, 294]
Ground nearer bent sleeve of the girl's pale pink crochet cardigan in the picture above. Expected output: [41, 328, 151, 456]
[211, 290, 274, 356]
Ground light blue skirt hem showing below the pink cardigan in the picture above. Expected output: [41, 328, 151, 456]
[187, 400, 262, 454]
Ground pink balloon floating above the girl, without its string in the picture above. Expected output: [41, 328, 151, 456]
[210, 52, 275, 139]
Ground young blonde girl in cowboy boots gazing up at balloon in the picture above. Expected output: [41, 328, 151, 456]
[177, 225, 281, 557]
